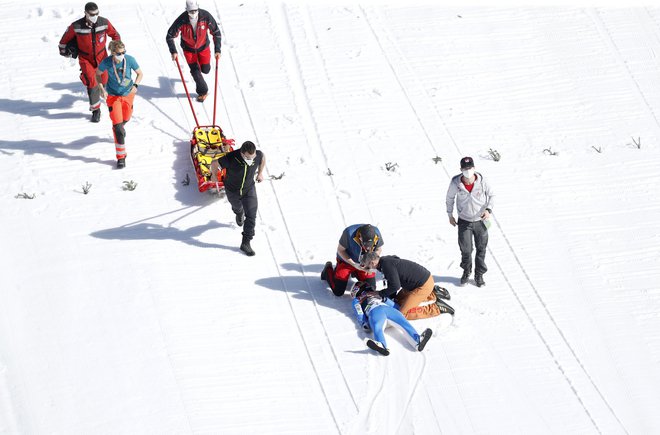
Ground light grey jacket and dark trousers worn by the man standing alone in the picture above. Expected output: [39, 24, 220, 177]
[446, 172, 495, 275]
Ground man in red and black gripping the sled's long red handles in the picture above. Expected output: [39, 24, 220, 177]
[166, 0, 222, 102]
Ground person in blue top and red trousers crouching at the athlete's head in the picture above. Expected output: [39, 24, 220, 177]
[321, 224, 383, 296]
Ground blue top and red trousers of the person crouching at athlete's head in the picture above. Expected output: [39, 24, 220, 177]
[326, 224, 383, 296]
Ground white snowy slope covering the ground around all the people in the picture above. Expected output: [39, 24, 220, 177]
[0, 0, 660, 434]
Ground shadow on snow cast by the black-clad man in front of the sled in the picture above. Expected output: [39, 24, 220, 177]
[90, 221, 239, 252]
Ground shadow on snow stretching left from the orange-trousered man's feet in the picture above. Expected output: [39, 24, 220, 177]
[0, 132, 115, 165]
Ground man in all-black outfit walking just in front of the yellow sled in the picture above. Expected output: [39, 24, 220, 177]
[218, 141, 266, 257]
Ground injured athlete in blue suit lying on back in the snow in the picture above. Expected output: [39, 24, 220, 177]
[351, 282, 433, 355]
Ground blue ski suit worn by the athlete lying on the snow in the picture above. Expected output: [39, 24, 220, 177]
[353, 291, 420, 349]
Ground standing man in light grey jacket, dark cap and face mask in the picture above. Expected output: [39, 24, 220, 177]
[446, 157, 495, 287]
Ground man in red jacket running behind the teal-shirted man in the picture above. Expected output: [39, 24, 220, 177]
[59, 2, 120, 122]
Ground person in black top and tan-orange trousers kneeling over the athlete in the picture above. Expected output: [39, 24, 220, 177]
[363, 252, 454, 320]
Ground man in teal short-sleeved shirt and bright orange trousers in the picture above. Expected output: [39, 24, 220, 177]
[96, 41, 142, 169]
